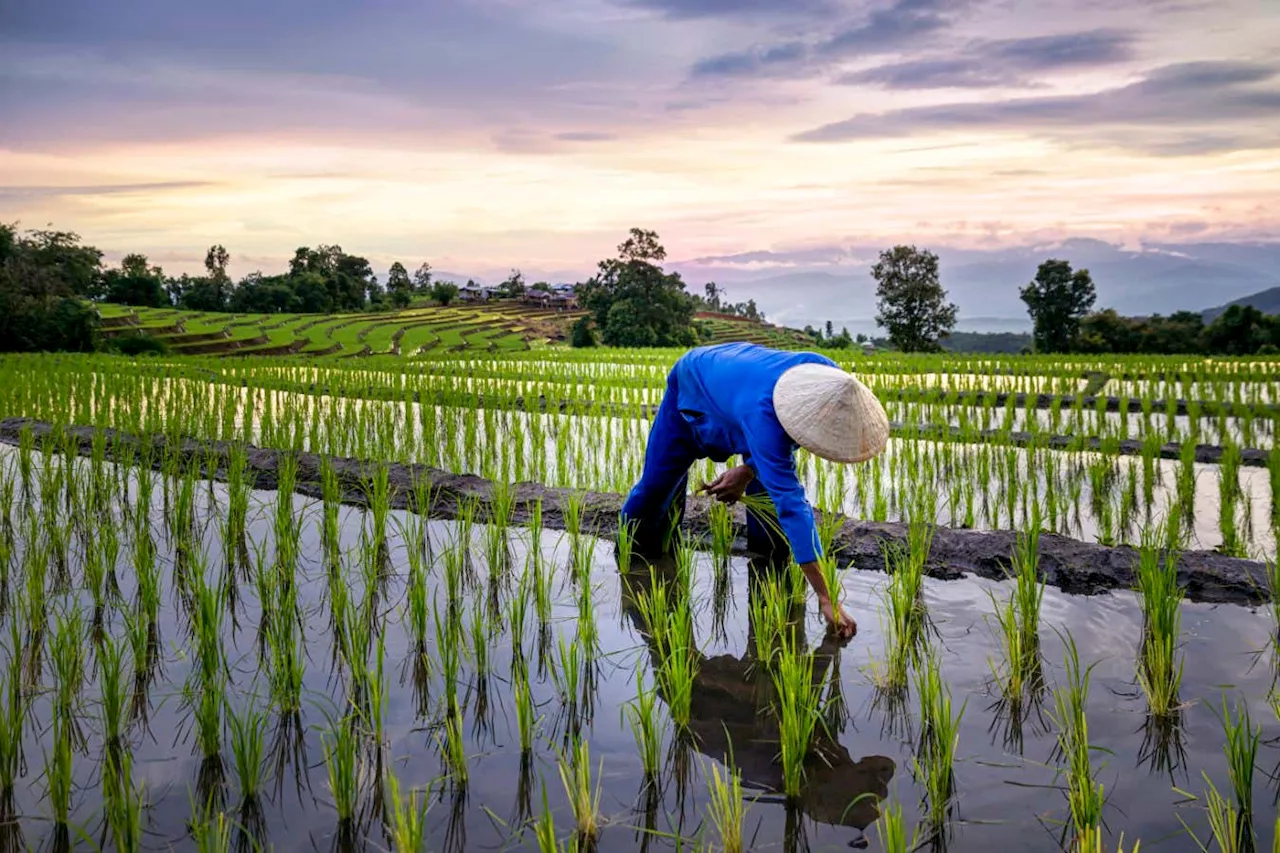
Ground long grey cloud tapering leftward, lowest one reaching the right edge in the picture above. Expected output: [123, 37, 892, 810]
[791, 61, 1280, 154]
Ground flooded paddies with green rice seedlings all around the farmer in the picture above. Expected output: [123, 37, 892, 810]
[0, 345, 1280, 853]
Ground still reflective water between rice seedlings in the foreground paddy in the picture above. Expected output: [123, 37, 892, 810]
[2, 458, 1280, 850]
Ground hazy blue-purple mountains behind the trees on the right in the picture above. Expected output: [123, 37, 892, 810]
[669, 238, 1280, 333]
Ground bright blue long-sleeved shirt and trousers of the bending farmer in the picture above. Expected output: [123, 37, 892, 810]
[622, 343, 836, 564]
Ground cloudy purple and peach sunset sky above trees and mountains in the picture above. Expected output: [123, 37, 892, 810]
[0, 0, 1280, 278]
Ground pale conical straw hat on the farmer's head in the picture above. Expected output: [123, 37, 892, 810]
[773, 364, 888, 462]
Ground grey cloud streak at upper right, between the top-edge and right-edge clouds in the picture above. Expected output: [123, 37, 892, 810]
[836, 29, 1135, 90]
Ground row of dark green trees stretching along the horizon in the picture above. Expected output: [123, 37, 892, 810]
[0, 224, 1280, 355]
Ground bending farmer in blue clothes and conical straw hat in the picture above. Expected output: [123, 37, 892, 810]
[622, 343, 888, 639]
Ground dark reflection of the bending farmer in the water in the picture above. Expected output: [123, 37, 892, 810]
[620, 556, 895, 849]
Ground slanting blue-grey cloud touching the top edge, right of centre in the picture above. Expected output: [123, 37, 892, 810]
[691, 0, 961, 78]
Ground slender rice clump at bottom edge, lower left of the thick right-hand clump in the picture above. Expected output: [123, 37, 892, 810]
[1053, 634, 1103, 852]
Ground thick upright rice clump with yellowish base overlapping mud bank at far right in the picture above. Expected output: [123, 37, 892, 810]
[1138, 532, 1183, 717]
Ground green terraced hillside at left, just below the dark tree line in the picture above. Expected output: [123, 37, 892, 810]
[100, 304, 581, 359]
